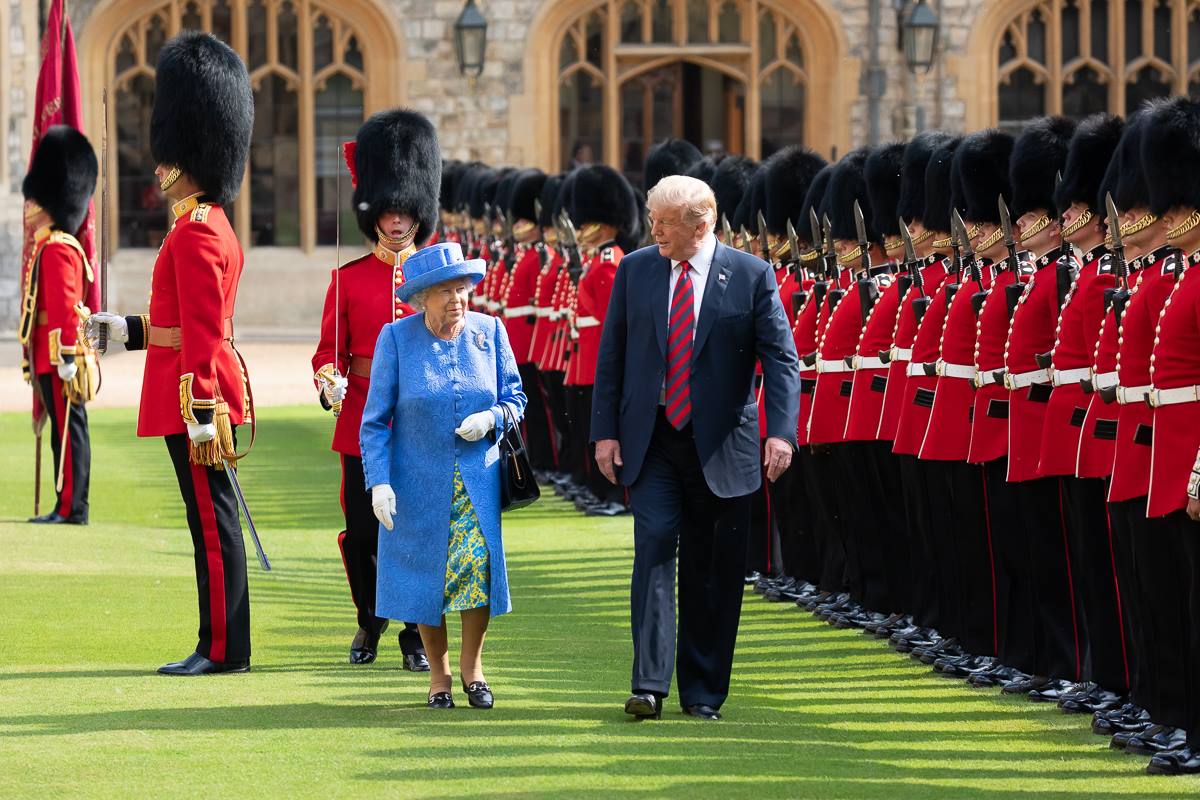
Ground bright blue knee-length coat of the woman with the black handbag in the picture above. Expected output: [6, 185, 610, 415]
[359, 312, 526, 625]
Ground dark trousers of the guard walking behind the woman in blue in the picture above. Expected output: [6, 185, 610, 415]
[337, 455, 424, 652]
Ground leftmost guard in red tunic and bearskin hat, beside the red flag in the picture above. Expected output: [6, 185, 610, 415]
[19, 125, 97, 525]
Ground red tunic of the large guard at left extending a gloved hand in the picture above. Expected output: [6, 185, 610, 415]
[128, 196, 251, 437]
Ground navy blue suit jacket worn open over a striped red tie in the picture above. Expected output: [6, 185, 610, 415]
[592, 243, 800, 498]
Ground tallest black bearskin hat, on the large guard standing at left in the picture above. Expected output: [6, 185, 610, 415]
[150, 31, 253, 205]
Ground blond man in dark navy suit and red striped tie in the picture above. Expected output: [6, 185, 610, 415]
[592, 175, 800, 720]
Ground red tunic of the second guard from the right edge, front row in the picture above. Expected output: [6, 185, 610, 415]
[1109, 247, 1183, 503]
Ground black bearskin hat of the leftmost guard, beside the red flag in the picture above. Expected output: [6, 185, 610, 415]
[20, 125, 98, 235]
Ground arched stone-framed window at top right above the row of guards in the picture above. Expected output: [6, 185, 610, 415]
[965, 0, 1200, 131]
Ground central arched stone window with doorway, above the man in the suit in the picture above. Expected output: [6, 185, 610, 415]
[532, 0, 853, 182]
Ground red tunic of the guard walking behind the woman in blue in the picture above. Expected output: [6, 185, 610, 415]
[312, 245, 415, 456]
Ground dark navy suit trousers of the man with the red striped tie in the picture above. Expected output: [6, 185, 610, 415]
[630, 409, 750, 708]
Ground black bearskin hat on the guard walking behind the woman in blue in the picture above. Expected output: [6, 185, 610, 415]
[354, 108, 442, 247]
